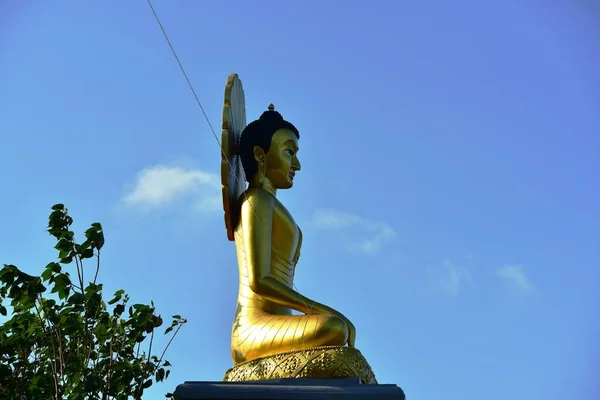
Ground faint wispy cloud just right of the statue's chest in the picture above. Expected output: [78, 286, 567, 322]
[312, 210, 396, 254]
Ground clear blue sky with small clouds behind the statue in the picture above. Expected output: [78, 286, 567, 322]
[0, 0, 600, 400]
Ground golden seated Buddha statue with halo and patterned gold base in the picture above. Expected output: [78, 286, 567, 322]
[221, 74, 376, 383]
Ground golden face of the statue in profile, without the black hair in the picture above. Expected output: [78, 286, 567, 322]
[255, 129, 300, 189]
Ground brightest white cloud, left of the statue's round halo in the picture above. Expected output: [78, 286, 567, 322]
[123, 165, 221, 211]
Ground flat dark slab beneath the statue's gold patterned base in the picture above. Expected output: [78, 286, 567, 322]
[175, 378, 406, 400]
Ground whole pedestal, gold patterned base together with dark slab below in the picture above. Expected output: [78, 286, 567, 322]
[175, 346, 405, 400]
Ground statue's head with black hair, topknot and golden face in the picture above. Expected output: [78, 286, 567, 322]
[240, 104, 300, 189]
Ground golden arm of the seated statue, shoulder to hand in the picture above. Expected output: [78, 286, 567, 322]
[241, 190, 338, 318]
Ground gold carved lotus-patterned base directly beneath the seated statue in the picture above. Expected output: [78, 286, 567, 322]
[223, 346, 377, 384]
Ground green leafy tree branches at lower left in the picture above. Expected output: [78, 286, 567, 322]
[0, 204, 186, 400]
